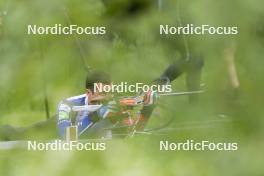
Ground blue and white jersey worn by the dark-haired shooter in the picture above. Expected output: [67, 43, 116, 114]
[57, 94, 112, 138]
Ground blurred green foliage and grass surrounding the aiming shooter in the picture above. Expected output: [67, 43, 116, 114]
[0, 0, 264, 176]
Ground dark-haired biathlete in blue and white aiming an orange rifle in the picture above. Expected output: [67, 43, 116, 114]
[57, 71, 156, 138]
